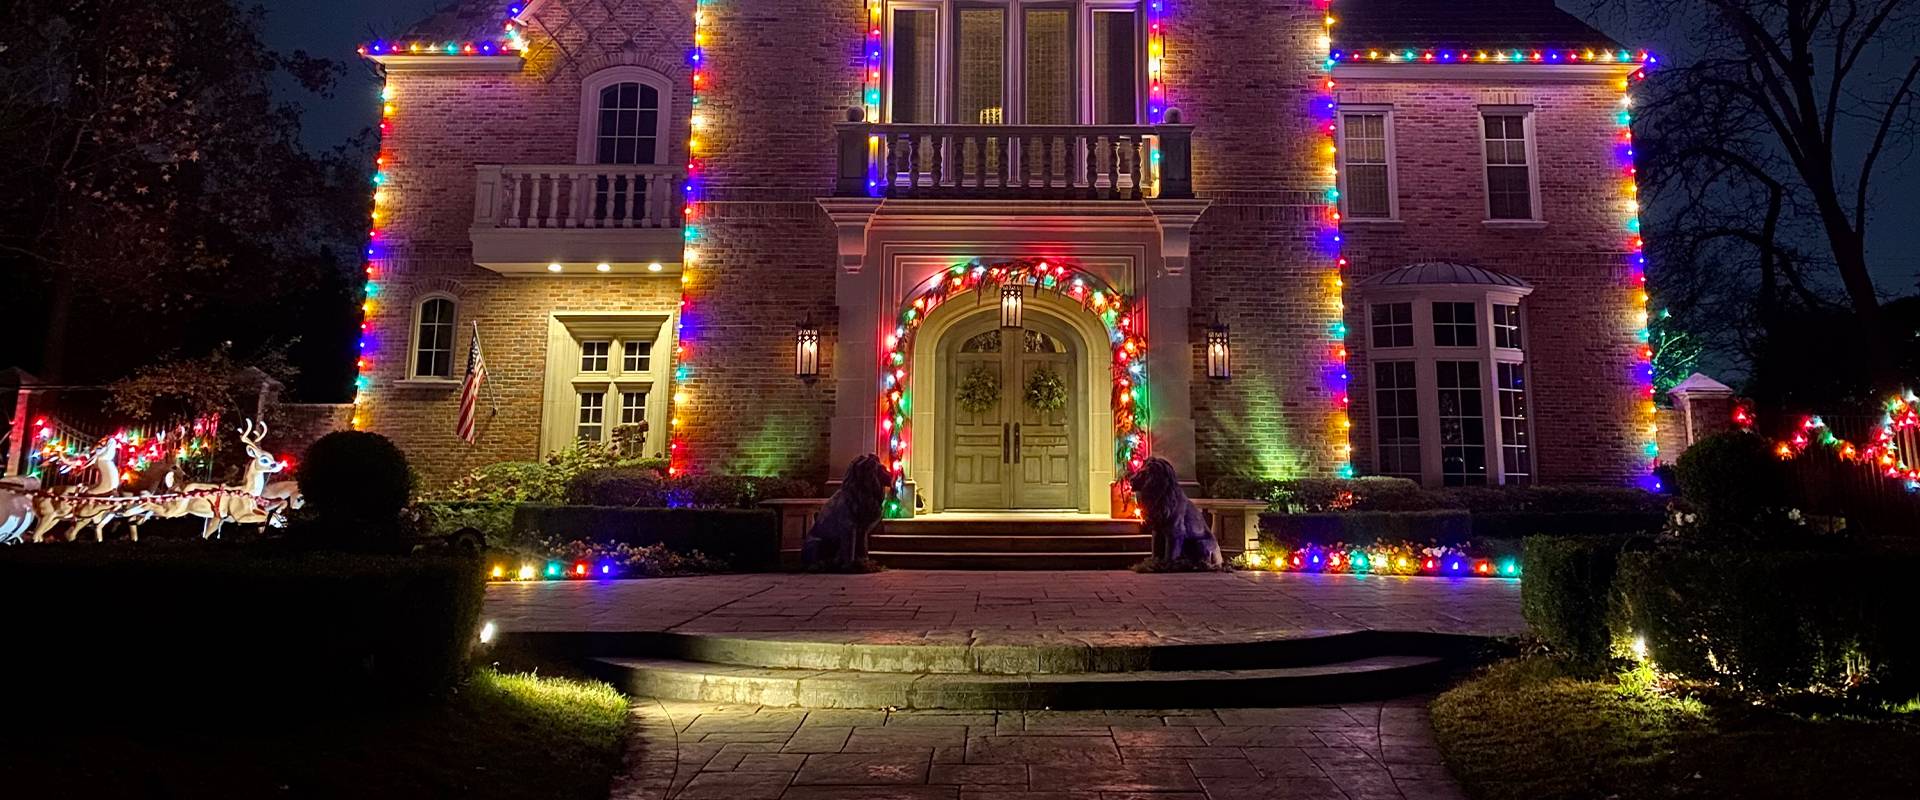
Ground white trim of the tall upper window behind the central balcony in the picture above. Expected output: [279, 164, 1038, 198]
[879, 0, 1150, 125]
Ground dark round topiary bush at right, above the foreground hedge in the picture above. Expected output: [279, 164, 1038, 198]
[1674, 432, 1791, 529]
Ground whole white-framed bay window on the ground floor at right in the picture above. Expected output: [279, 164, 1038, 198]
[1357, 263, 1534, 485]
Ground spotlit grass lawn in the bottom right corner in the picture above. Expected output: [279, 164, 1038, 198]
[1432, 656, 1920, 800]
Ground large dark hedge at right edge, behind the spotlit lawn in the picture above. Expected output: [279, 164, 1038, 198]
[1620, 551, 1920, 700]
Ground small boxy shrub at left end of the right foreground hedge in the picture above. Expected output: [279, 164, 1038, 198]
[1521, 535, 1645, 671]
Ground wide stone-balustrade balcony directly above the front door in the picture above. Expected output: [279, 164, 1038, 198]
[833, 111, 1192, 201]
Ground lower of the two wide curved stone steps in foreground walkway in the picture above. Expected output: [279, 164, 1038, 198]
[588, 656, 1452, 710]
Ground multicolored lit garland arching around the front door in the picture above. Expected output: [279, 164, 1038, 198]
[877, 259, 1150, 516]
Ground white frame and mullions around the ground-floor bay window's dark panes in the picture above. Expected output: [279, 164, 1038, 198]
[1365, 284, 1540, 487]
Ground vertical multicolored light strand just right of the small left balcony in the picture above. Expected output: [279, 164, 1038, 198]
[666, 0, 714, 476]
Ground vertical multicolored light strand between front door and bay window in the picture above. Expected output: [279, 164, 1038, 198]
[1309, 0, 1354, 478]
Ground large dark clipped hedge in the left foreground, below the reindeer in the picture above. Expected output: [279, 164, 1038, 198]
[0, 543, 484, 714]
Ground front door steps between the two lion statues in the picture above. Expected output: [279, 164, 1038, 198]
[868, 516, 1154, 570]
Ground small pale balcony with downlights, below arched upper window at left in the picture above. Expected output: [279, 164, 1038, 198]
[472, 163, 685, 274]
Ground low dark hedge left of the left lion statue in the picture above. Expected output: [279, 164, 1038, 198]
[513, 505, 780, 570]
